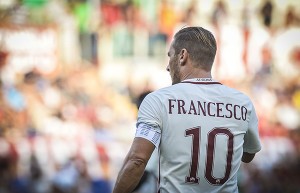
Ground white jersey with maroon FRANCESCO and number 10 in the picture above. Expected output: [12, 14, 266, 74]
[136, 79, 261, 193]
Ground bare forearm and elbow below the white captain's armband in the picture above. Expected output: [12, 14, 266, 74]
[113, 137, 155, 193]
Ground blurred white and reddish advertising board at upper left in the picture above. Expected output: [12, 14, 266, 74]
[0, 25, 58, 74]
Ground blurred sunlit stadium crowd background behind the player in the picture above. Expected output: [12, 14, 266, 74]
[0, 0, 300, 193]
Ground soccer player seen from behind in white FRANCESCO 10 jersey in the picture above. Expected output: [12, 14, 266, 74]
[113, 27, 261, 193]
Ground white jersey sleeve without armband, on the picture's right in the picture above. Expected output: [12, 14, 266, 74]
[243, 105, 261, 153]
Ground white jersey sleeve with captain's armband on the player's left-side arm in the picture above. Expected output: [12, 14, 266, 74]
[135, 93, 162, 147]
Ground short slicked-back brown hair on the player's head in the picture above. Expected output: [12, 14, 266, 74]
[173, 27, 217, 71]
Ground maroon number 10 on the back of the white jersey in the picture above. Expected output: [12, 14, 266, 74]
[185, 127, 233, 185]
